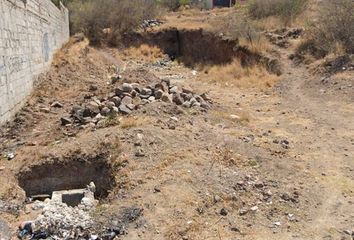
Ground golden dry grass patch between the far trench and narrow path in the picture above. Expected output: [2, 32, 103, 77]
[203, 60, 279, 89]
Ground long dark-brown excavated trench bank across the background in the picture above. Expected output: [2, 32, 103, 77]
[123, 28, 281, 75]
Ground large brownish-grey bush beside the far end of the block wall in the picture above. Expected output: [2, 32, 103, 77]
[69, 0, 157, 45]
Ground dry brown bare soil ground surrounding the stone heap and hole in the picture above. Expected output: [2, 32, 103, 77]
[0, 10, 354, 239]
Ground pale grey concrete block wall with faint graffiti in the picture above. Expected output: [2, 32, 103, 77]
[0, 0, 69, 124]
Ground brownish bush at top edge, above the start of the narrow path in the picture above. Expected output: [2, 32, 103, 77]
[248, 0, 309, 24]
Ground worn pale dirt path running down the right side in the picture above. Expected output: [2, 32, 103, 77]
[274, 47, 354, 239]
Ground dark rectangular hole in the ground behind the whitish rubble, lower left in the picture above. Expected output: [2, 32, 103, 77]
[18, 157, 115, 201]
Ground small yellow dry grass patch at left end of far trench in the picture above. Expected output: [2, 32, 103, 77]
[123, 44, 164, 62]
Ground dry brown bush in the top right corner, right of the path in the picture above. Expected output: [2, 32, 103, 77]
[308, 0, 354, 53]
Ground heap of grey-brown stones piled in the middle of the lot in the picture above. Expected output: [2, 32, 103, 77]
[61, 80, 211, 126]
